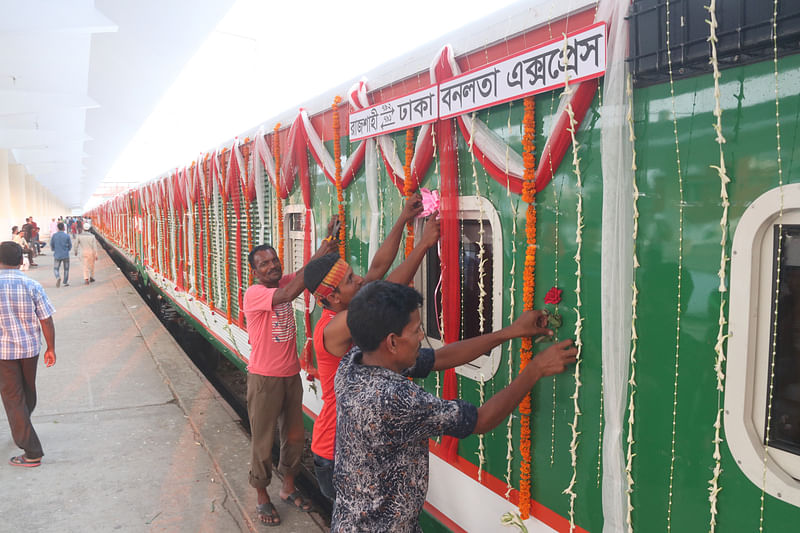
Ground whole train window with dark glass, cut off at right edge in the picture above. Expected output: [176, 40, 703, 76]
[725, 183, 800, 505]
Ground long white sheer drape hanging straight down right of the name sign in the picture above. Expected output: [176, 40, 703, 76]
[596, 0, 633, 533]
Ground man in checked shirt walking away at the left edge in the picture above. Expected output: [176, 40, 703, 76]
[0, 241, 56, 467]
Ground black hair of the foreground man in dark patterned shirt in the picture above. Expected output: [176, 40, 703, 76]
[347, 281, 422, 352]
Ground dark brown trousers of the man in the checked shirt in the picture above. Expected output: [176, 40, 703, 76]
[0, 355, 44, 459]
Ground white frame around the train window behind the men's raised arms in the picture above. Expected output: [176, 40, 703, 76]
[414, 196, 503, 381]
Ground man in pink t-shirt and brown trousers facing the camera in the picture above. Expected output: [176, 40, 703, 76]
[244, 222, 338, 526]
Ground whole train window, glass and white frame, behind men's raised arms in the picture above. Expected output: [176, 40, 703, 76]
[414, 196, 503, 381]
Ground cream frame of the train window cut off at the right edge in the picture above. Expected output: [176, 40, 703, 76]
[725, 183, 800, 505]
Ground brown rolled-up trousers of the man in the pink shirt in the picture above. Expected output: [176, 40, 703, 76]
[247, 374, 305, 489]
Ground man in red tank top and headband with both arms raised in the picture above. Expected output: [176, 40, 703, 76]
[303, 194, 439, 500]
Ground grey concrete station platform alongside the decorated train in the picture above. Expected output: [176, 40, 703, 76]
[0, 243, 326, 533]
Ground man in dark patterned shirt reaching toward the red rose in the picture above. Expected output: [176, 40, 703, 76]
[331, 281, 577, 533]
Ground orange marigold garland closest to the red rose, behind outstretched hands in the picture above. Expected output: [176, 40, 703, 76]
[519, 96, 536, 520]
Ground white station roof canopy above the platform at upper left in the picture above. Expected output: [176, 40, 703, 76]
[0, 0, 234, 209]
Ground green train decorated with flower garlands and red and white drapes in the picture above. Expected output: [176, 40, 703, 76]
[87, 0, 800, 532]
